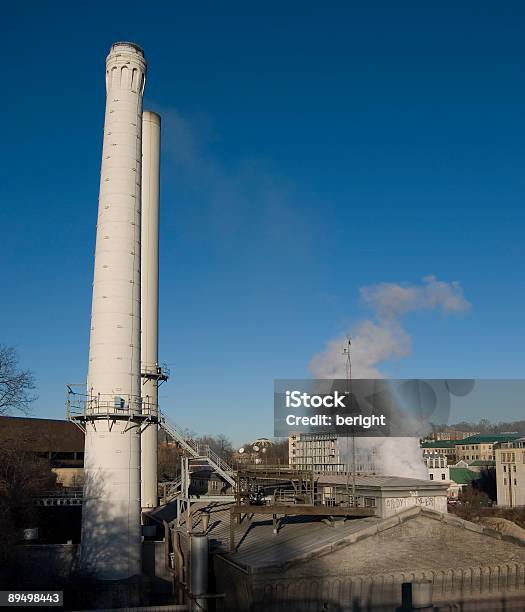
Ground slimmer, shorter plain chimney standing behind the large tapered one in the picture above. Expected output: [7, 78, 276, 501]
[141, 111, 160, 509]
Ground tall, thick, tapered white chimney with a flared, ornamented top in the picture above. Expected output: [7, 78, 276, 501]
[80, 43, 146, 580]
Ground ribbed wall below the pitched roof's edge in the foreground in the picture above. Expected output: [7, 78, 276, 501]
[215, 557, 525, 612]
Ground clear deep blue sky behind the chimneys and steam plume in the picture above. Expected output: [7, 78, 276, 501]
[0, 2, 525, 442]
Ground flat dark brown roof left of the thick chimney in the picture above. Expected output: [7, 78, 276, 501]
[0, 416, 84, 453]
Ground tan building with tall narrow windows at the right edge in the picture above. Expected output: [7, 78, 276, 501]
[494, 438, 525, 508]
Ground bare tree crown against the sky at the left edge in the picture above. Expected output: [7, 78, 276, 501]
[0, 344, 36, 415]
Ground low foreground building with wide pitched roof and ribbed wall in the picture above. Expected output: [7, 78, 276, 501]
[167, 503, 525, 612]
